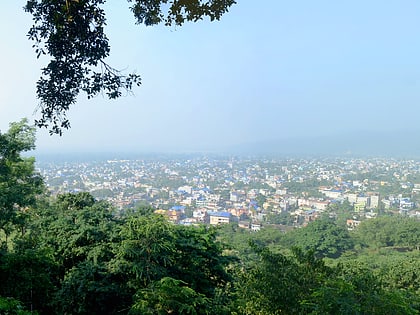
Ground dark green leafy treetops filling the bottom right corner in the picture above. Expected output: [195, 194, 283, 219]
[237, 247, 418, 315]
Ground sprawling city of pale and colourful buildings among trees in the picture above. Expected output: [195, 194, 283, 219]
[38, 156, 420, 230]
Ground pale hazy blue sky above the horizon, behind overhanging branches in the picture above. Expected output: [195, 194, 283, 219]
[0, 0, 420, 151]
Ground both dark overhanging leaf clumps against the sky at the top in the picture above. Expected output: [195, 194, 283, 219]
[25, 0, 235, 135]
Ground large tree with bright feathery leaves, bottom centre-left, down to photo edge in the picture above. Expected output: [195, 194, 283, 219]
[110, 215, 233, 314]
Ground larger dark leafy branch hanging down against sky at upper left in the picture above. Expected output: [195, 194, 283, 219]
[25, 0, 141, 134]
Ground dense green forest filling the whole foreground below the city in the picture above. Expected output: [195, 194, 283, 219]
[0, 120, 420, 315]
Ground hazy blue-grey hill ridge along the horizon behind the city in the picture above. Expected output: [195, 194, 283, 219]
[30, 131, 420, 158]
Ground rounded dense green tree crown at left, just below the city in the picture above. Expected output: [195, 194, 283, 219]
[30, 193, 119, 272]
